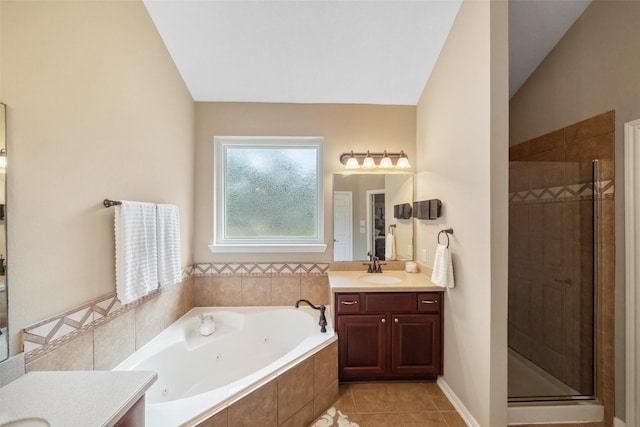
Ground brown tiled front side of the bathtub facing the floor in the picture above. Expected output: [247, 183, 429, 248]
[197, 341, 339, 427]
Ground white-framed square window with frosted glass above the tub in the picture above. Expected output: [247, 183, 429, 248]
[210, 136, 327, 252]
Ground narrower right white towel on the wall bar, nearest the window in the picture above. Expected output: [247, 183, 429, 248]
[157, 205, 182, 286]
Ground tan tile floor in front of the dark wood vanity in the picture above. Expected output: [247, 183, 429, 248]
[312, 382, 466, 427]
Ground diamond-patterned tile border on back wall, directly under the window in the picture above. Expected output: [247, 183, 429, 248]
[193, 263, 329, 277]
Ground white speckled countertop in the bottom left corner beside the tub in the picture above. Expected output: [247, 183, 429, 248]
[0, 371, 158, 426]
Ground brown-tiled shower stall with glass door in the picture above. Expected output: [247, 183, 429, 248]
[508, 112, 614, 416]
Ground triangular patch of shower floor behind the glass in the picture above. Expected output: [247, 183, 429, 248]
[507, 349, 580, 399]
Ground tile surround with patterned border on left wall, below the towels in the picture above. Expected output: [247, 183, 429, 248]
[22, 276, 193, 372]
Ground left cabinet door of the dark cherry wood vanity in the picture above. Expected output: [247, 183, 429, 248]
[338, 314, 387, 379]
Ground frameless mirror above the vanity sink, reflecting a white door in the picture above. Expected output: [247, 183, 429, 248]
[333, 173, 413, 261]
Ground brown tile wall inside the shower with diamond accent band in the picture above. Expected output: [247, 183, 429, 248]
[509, 111, 615, 419]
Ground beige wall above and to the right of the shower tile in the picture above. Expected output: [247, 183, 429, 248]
[510, 1, 640, 419]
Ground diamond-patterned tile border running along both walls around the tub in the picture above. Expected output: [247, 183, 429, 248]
[22, 263, 329, 363]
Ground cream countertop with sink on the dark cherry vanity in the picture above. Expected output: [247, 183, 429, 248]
[328, 270, 444, 292]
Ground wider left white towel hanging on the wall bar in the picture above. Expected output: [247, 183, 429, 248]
[115, 201, 158, 304]
